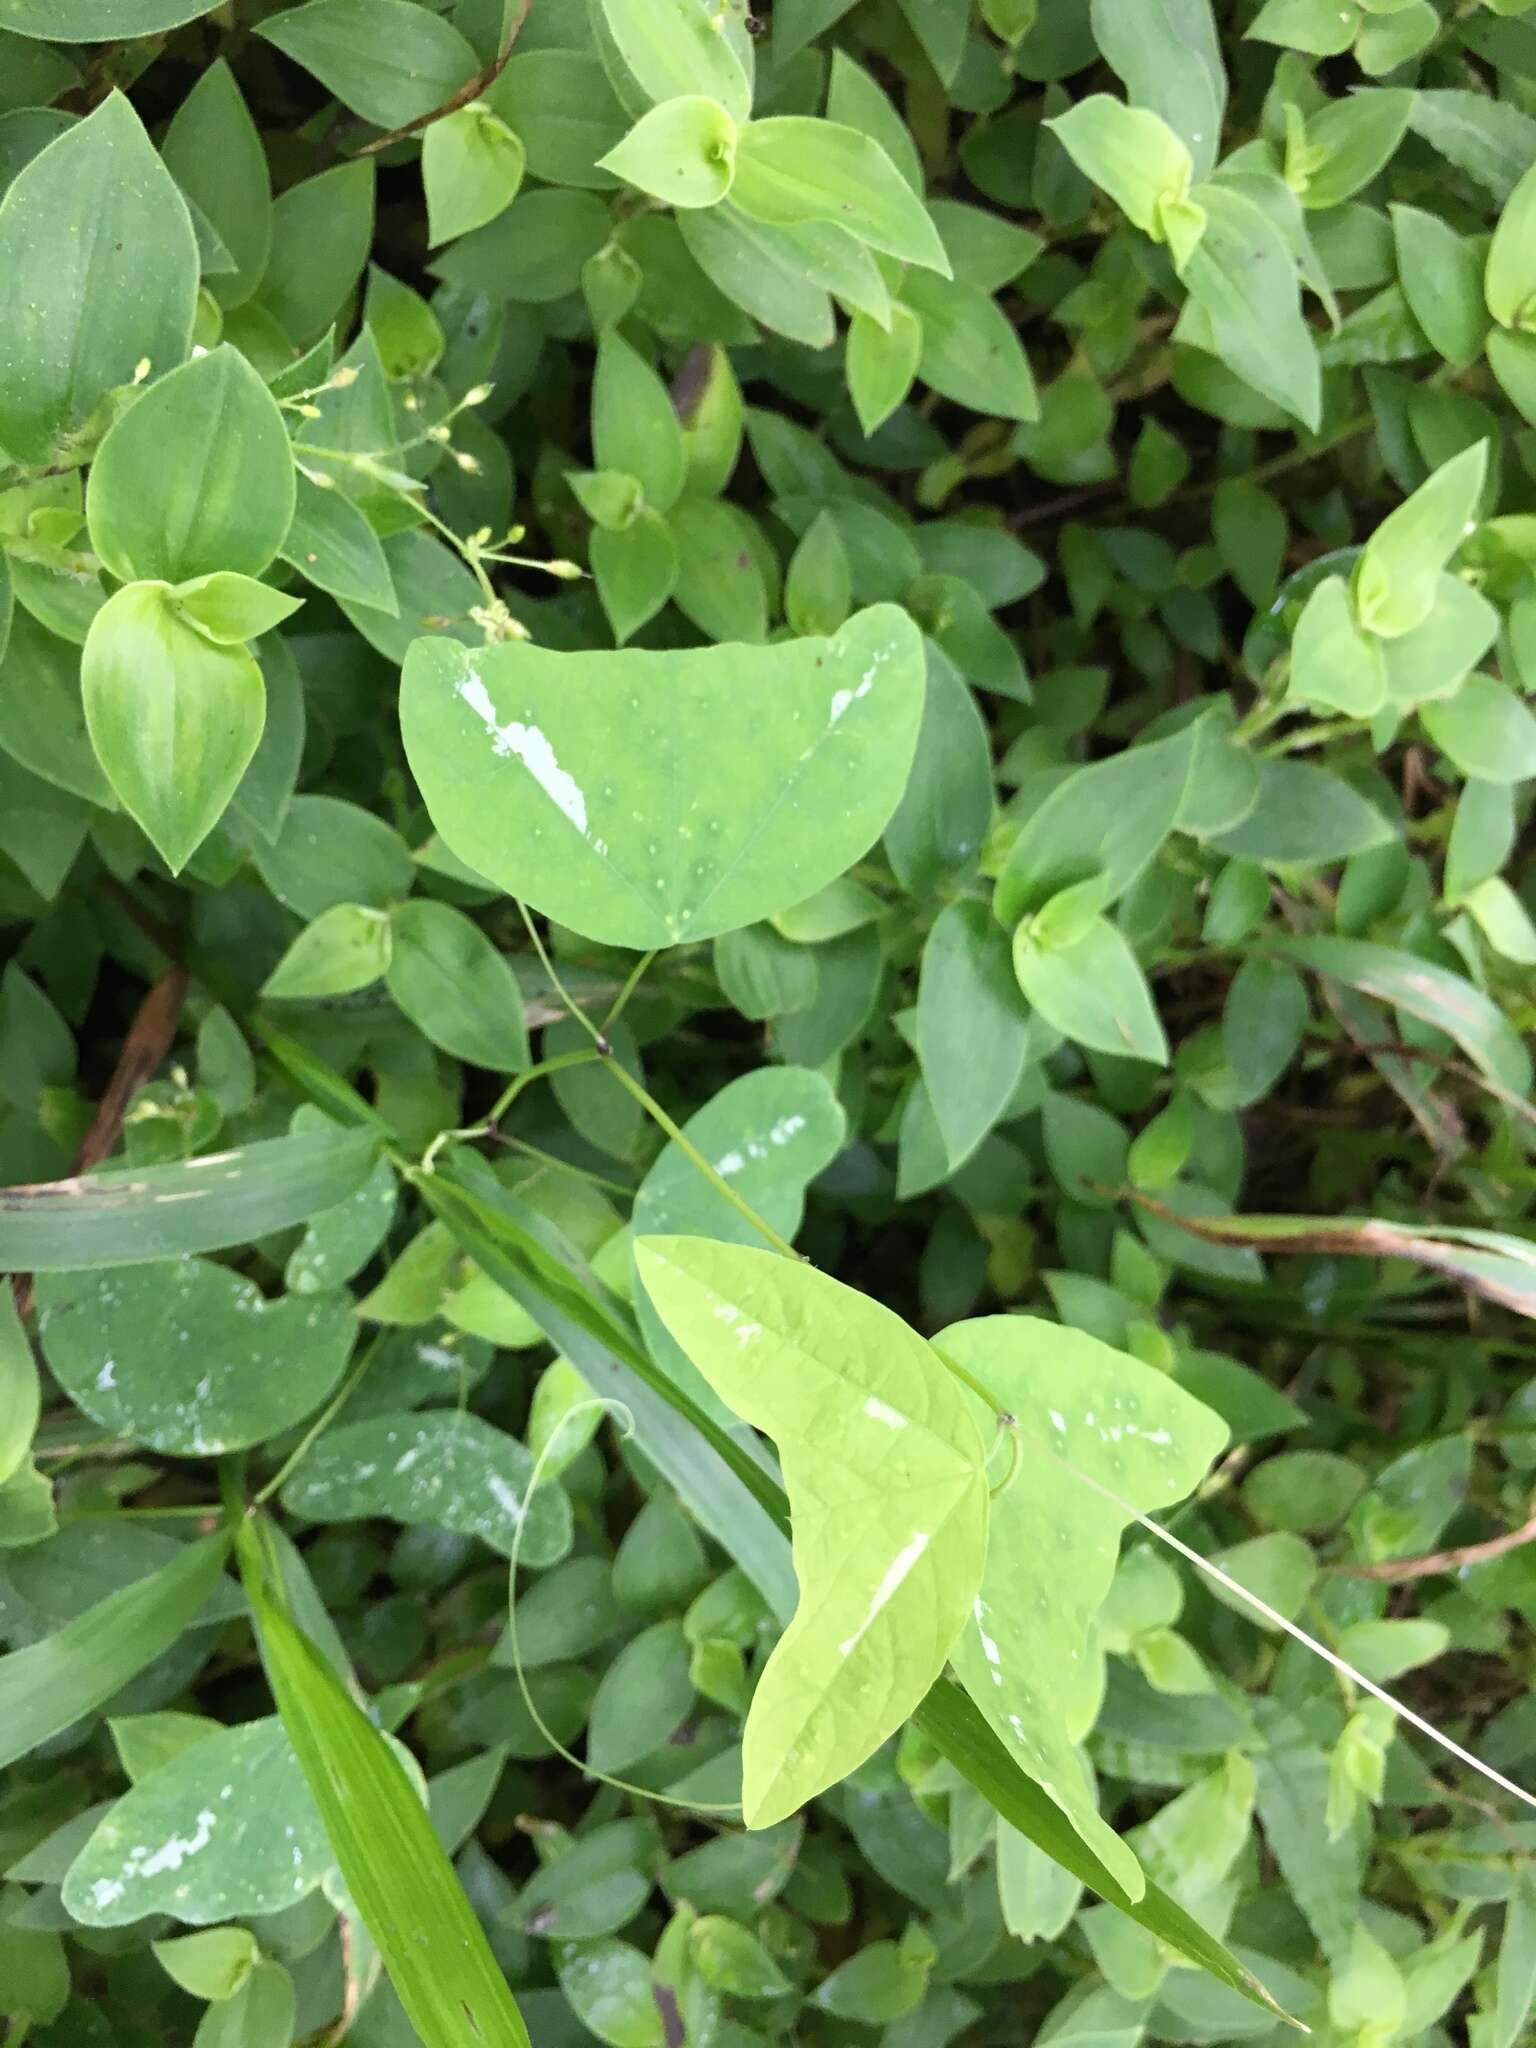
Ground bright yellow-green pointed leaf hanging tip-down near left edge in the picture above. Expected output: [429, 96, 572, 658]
[80, 584, 266, 872]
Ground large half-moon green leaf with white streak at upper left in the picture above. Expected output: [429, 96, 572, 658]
[401, 606, 922, 948]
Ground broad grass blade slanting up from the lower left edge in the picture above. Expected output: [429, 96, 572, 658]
[0, 1534, 229, 1767]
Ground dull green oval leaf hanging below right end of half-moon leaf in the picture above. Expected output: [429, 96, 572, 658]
[918, 903, 1030, 1167]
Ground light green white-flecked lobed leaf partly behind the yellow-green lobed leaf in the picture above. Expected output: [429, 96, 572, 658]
[934, 1315, 1227, 1898]
